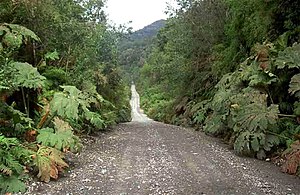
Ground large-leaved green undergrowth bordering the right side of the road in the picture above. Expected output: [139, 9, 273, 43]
[142, 39, 300, 174]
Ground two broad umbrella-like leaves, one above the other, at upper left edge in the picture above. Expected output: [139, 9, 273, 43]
[0, 24, 45, 90]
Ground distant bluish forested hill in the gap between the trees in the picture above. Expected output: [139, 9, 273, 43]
[118, 20, 166, 80]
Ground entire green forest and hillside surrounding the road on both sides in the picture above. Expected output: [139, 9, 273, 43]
[0, 0, 300, 194]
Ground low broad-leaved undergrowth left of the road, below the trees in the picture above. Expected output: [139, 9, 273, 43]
[0, 20, 130, 194]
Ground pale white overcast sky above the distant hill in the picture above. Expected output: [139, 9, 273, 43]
[105, 0, 173, 30]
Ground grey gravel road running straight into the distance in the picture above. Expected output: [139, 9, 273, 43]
[26, 86, 300, 195]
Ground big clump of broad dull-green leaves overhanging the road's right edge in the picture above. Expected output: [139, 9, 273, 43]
[204, 50, 280, 155]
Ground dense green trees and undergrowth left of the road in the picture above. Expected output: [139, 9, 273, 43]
[0, 0, 130, 194]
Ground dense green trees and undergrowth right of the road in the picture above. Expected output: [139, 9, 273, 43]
[137, 0, 300, 174]
